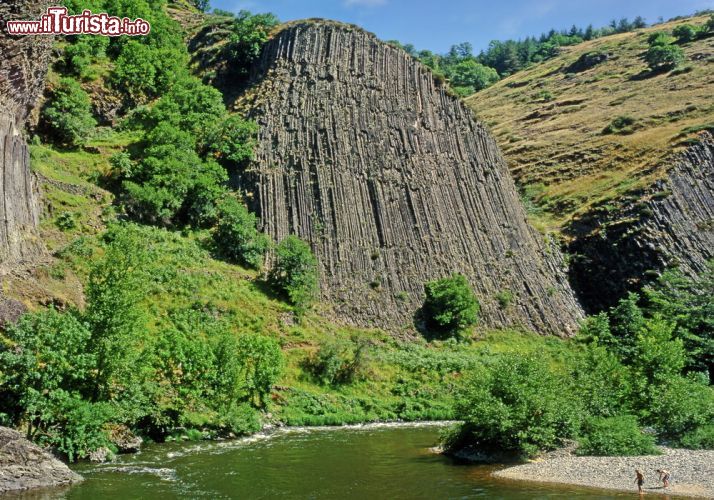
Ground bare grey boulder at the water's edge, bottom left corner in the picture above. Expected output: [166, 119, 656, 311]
[0, 427, 82, 494]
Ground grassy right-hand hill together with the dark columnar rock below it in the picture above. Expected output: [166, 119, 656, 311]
[466, 15, 714, 313]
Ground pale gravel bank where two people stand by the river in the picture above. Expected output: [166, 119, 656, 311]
[494, 448, 714, 498]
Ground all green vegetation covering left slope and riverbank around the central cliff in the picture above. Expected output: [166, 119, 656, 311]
[0, 0, 714, 460]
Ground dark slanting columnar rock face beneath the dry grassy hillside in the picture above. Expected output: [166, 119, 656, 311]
[570, 132, 714, 311]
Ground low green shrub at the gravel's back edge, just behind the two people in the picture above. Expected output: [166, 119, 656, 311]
[577, 415, 657, 456]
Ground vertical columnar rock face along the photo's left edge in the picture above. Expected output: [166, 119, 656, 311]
[0, 0, 52, 265]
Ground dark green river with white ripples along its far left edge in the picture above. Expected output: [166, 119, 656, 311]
[23, 424, 632, 500]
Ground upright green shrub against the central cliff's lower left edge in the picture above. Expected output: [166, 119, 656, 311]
[269, 235, 318, 312]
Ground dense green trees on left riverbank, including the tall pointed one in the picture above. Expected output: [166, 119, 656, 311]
[0, 225, 283, 460]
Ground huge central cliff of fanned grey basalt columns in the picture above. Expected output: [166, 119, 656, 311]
[240, 20, 581, 335]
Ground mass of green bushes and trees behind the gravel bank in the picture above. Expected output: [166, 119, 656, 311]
[447, 268, 714, 456]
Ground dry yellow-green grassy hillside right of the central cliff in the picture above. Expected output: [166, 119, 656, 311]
[467, 16, 714, 231]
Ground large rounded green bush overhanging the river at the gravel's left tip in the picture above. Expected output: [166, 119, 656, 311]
[450, 355, 582, 456]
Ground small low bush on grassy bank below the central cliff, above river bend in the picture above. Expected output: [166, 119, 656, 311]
[305, 339, 367, 385]
